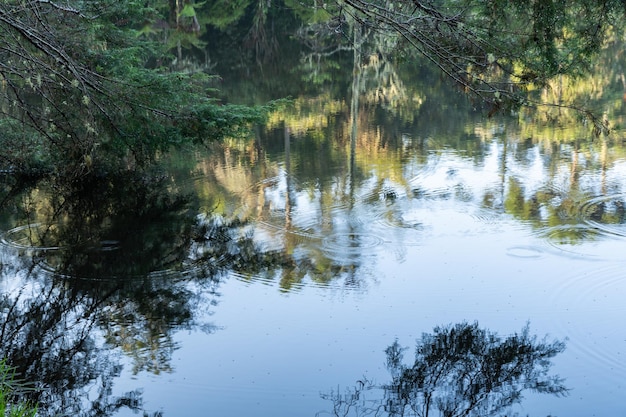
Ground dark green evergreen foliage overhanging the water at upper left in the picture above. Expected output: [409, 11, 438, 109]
[0, 0, 264, 176]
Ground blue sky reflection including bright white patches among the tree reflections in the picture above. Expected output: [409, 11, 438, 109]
[111, 136, 626, 416]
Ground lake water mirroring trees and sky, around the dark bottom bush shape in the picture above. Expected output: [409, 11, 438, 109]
[0, 39, 626, 417]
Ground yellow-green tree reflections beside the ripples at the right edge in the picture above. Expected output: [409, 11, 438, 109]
[483, 138, 624, 243]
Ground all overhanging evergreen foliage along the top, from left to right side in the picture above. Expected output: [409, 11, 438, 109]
[0, 0, 625, 177]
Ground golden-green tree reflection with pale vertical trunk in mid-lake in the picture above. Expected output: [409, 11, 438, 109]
[202, 45, 486, 290]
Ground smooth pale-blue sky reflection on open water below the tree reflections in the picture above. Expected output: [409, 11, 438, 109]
[113, 214, 626, 416]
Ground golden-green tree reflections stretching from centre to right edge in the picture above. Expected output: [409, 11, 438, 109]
[205, 15, 623, 280]
